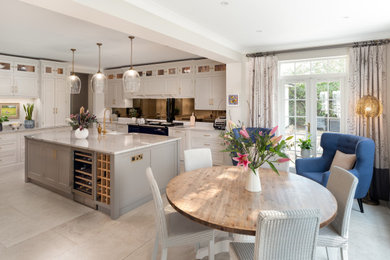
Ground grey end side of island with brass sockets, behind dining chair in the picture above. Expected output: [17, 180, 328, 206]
[111, 142, 179, 219]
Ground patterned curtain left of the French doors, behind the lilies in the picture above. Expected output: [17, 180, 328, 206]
[249, 55, 278, 127]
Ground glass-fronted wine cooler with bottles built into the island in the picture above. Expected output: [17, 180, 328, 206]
[73, 151, 93, 197]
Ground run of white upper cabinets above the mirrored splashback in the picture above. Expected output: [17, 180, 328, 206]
[105, 59, 226, 110]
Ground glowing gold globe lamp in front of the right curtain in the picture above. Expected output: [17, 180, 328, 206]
[356, 95, 383, 138]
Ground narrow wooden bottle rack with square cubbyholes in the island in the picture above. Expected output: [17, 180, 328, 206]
[96, 153, 111, 205]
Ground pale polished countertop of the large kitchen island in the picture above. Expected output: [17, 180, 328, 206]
[26, 129, 180, 154]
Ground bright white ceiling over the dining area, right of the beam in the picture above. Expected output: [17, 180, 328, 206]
[123, 0, 390, 53]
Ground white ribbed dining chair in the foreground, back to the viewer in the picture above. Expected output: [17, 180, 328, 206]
[230, 209, 320, 260]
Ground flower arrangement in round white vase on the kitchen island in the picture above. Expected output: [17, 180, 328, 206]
[69, 107, 97, 139]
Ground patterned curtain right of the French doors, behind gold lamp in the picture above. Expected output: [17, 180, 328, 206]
[347, 42, 390, 200]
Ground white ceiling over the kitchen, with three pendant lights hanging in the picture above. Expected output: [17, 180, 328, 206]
[0, 0, 198, 68]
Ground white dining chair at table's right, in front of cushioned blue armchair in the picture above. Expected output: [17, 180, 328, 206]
[317, 166, 359, 260]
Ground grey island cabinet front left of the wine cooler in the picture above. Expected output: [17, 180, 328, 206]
[26, 140, 72, 194]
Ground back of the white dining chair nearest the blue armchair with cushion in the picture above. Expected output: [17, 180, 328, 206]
[326, 166, 359, 238]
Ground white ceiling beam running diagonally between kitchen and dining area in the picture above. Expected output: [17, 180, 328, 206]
[21, 0, 246, 63]
